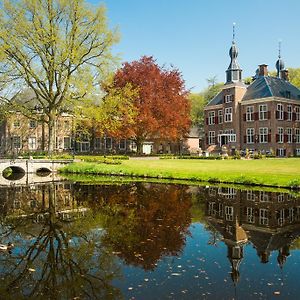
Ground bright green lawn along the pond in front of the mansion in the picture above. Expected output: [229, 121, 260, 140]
[61, 158, 300, 188]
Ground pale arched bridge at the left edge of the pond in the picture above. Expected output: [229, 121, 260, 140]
[0, 159, 73, 185]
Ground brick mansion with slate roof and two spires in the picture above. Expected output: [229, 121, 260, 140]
[204, 31, 300, 157]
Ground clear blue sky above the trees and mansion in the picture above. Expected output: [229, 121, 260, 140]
[89, 0, 300, 92]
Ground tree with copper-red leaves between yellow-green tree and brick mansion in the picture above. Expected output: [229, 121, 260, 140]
[113, 56, 190, 153]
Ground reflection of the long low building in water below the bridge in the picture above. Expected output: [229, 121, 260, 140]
[0, 182, 87, 222]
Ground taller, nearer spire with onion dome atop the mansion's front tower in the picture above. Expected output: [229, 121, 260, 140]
[226, 23, 242, 84]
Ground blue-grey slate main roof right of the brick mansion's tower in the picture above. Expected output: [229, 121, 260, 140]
[242, 76, 300, 101]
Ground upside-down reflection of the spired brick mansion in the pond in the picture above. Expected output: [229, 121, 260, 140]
[204, 187, 300, 283]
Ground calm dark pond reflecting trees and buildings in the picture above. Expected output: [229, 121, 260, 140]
[0, 181, 300, 299]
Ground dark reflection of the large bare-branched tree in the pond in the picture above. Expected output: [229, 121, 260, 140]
[0, 186, 120, 299]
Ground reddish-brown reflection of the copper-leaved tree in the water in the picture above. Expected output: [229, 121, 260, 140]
[81, 183, 191, 270]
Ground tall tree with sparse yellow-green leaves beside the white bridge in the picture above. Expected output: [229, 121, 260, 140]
[0, 0, 118, 153]
